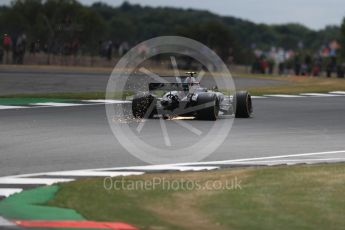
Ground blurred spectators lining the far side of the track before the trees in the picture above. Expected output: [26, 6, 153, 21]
[0, 33, 345, 78]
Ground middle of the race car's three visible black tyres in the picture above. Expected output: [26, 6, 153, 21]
[196, 93, 219, 121]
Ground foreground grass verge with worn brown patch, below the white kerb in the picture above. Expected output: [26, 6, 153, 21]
[48, 164, 345, 229]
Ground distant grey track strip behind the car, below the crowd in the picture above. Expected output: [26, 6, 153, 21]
[0, 66, 286, 95]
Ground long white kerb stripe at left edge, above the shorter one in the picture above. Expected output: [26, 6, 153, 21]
[0, 178, 73, 185]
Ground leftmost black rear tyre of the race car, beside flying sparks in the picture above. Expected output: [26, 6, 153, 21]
[132, 93, 157, 118]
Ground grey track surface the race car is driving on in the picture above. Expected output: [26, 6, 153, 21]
[0, 97, 345, 176]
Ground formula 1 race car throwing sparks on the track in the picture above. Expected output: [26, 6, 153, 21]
[132, 72, 253, 120]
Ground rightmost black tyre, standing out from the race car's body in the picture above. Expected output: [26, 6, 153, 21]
[233, 91, 253, 118]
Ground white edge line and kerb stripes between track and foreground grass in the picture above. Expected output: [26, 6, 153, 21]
[0, 150, 345, 197]
